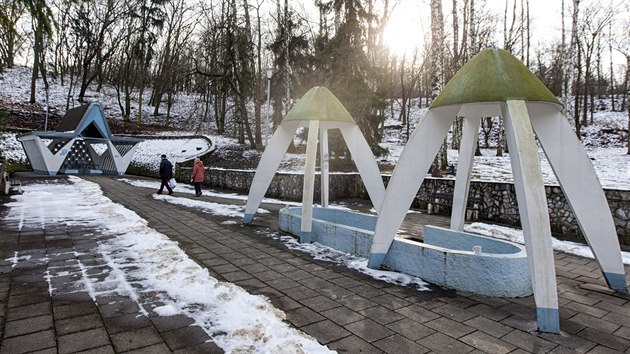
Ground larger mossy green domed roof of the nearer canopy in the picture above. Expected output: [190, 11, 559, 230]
[431, 48, 560, 108]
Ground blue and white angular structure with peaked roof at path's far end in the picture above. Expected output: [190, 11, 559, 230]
[18, 103, 142, 176]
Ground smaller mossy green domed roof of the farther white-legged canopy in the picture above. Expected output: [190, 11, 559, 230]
[283, 86, 355, 123]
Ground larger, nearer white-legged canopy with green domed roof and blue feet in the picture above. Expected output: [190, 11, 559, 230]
[368, 49, 627, 333]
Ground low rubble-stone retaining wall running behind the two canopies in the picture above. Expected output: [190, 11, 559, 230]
[176, 166, 630, 247]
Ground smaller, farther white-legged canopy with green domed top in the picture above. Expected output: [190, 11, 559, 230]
[244, 86, 385, 233]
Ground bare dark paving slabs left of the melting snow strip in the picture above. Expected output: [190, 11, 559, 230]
[0, 180, 223, 354]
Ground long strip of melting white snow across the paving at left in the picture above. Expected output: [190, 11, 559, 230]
[6, 176, 338, 353]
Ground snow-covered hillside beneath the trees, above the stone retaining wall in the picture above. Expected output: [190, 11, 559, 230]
[0, 67, 630, 189]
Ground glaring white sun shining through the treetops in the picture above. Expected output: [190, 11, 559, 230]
[383, 1, 424, 57]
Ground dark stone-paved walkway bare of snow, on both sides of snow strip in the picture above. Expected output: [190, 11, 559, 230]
[0, 176, 630, 353]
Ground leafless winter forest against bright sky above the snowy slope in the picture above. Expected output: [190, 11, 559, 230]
[0, 0, 630, 170]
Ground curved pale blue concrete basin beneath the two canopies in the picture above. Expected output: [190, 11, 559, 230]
[278, 207, 533, 297]
